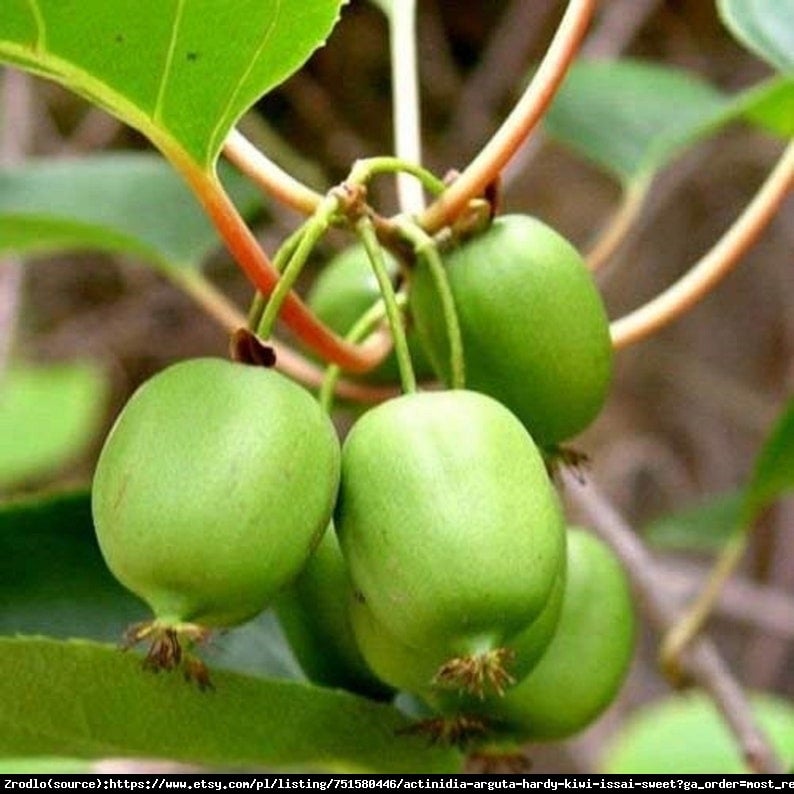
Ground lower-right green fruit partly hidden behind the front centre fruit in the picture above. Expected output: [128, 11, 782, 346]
[474, 529, 635, 742]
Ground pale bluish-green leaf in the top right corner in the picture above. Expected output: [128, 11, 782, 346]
[717, 0, 794, 72]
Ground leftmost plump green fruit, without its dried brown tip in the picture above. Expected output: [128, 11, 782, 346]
[92, 359, 340, 627]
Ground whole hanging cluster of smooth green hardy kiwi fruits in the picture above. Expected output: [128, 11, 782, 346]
[93, 212, 633, 741]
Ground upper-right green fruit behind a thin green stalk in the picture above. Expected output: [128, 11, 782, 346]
[409, 215, 612, 447]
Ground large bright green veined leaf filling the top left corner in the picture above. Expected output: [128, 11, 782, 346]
[0, 0, 343, 170]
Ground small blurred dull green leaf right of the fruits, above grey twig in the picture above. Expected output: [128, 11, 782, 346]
[642, 491, 744, 551]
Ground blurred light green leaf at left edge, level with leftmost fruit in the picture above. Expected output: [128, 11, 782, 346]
[0, 363, 106, 489]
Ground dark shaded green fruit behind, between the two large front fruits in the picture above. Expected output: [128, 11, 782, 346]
[275, 526, 394, 700]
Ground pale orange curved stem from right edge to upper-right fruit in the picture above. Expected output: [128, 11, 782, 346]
[611, 141, 794, 348]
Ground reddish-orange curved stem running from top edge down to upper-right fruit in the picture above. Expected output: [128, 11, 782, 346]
[420, 0, 596, 233]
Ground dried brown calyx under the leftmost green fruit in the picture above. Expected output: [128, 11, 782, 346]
[122, 620, 213, 690]
